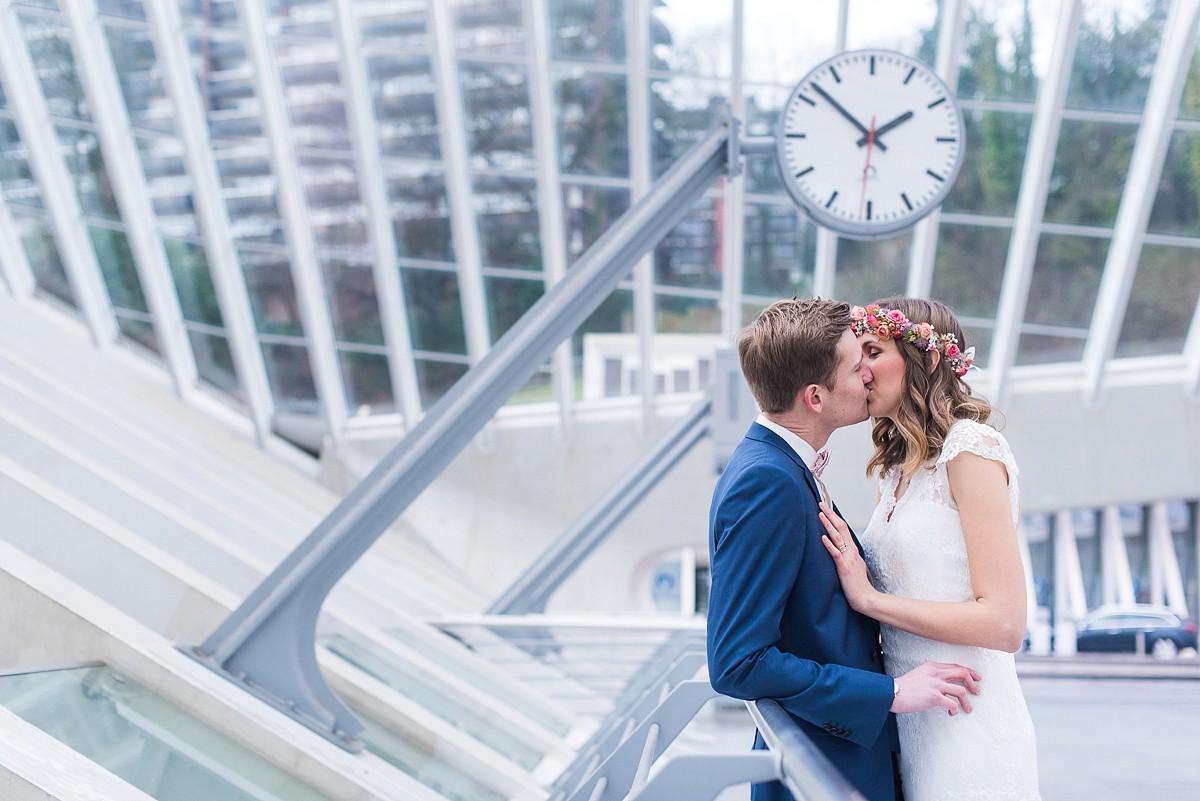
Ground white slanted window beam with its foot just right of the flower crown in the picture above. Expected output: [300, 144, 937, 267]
[986, 0, 1082, 406]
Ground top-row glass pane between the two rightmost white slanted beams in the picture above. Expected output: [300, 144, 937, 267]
[1067, 0, 1166, 112]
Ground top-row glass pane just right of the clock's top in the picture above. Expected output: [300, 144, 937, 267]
[958, 0, 1041, 104]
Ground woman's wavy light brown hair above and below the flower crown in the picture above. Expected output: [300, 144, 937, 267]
[866, 296, 1000, 476]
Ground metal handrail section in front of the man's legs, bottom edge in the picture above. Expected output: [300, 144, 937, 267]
[746, 698, 866, 801]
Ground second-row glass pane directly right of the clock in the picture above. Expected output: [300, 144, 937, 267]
[944, 112, 1033, 216]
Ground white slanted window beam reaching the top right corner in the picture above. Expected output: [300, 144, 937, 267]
[1084, 0, 1200, 404]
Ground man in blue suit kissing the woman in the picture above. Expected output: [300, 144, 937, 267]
[708, 299, 979, 801]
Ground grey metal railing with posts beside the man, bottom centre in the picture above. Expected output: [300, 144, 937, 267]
[437, 615, 865, 801]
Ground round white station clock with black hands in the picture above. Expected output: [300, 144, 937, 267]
[775, 50, 962, 239]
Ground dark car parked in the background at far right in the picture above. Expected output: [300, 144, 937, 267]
[1075, 603, 1196, 660]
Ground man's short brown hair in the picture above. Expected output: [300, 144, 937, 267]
[737, 297, 851, 414]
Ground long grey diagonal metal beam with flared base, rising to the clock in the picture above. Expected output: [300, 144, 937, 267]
[186, 122, 731, 751]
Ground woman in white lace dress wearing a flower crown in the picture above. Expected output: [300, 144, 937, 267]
[821, 297, 1040, 801]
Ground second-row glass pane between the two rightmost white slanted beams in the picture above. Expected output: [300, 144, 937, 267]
[1045, 120, 1138, 227]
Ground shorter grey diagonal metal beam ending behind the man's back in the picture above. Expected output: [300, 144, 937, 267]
[487, 398, 713, 615]
